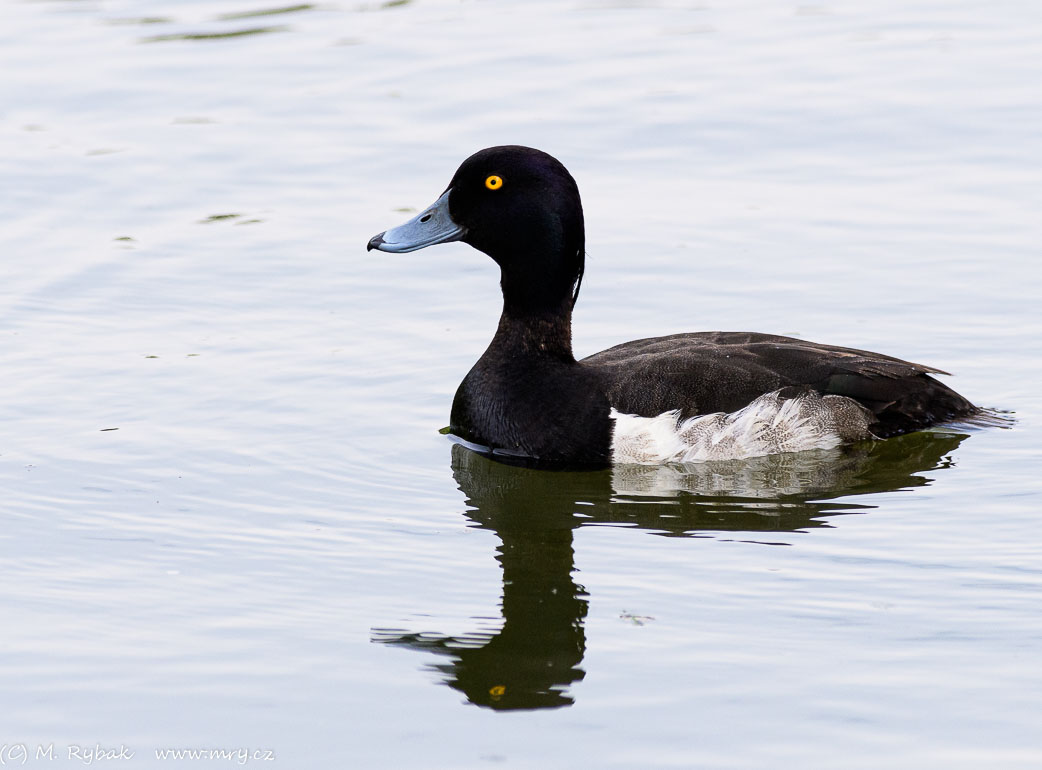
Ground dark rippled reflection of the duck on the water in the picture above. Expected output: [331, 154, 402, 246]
[372, 431, 966, 710]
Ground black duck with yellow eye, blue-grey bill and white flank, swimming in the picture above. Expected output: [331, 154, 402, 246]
[367, 145, 982, 468]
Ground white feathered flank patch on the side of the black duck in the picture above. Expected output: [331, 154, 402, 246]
[612, 391, 874, 465]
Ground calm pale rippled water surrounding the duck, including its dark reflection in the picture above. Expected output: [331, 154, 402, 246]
[0, 0, 1042, 769]
